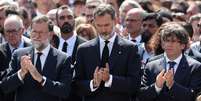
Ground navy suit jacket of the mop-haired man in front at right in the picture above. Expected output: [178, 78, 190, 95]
[139, 55, 201, 101]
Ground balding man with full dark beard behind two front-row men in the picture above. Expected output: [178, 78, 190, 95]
[56, 5, 86, 101]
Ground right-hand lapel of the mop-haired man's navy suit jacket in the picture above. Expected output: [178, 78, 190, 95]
[174, 55, 190, 83]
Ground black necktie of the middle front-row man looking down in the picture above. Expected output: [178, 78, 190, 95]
[101, 40, 109, 67]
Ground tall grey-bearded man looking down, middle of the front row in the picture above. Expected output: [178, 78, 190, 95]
[75, 4, 141, 101]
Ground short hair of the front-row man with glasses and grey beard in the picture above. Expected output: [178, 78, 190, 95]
[31, 15, 54, 32]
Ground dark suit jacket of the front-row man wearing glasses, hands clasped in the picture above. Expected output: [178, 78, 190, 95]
[0, 47, 72, 101]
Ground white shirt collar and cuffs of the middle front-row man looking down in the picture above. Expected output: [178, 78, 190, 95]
[90, 32, 117, 92]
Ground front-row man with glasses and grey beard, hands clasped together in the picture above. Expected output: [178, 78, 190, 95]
[0, 15, 72, 101]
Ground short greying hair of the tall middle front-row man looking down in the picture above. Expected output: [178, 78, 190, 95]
[93, 3, 116, 20]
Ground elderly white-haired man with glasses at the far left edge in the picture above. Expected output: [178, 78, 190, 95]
[0, 15, 31, 101]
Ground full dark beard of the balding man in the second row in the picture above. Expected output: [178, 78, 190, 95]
[61, 22, 74, 33]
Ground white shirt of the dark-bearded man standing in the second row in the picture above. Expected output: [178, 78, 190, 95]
[58, 32, 77, 56]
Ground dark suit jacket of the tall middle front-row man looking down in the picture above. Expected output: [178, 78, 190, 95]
[75, 36, 141, 101]
